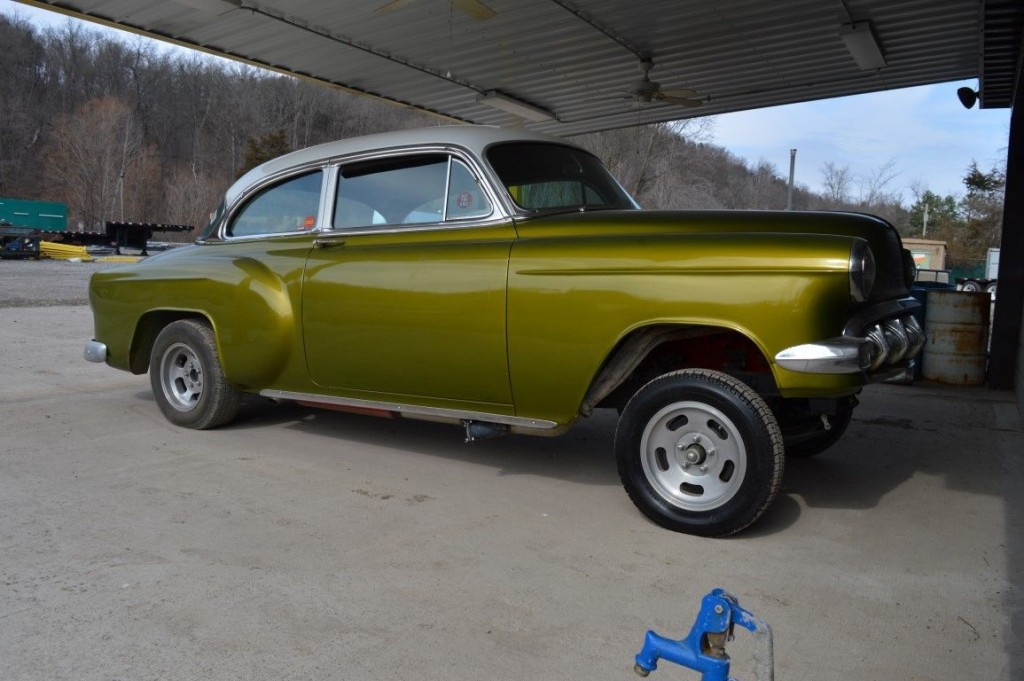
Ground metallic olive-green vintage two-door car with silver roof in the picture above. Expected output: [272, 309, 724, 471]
[86, 126, 925, 536]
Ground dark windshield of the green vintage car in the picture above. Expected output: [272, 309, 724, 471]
[487, 142, 637, 212]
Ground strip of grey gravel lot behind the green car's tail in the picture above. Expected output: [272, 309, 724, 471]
[0, 260, 134, 307]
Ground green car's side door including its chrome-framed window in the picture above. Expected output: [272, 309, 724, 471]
[302, 152, 515, 414]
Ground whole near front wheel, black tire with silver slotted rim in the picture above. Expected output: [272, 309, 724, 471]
[615, 369, 785, 537]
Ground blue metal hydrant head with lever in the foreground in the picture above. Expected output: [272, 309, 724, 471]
[633, 589, 775, 681]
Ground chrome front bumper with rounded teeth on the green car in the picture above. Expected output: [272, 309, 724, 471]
[775, 314, 925, 374]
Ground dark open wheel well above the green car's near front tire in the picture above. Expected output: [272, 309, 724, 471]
[581, 325, 778, 416]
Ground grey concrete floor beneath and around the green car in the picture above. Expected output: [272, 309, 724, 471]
[0, 305, 1024, 681]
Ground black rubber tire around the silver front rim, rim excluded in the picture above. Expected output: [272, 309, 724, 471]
[615, 372, 782, 537]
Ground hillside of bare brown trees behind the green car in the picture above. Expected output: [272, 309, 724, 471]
[0, 15, 958, 244]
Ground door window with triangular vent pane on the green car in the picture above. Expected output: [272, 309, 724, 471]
[333, 154, 493, 229]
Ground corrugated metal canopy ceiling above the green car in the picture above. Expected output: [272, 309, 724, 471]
[16, 0, 1024, 135]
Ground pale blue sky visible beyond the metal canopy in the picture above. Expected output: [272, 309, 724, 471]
[0, 0, 1010, 204]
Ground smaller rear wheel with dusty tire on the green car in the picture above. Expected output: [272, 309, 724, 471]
[150, 320, 242, 430]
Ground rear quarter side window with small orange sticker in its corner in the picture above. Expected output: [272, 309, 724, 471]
[227, 170, 324, 237]
